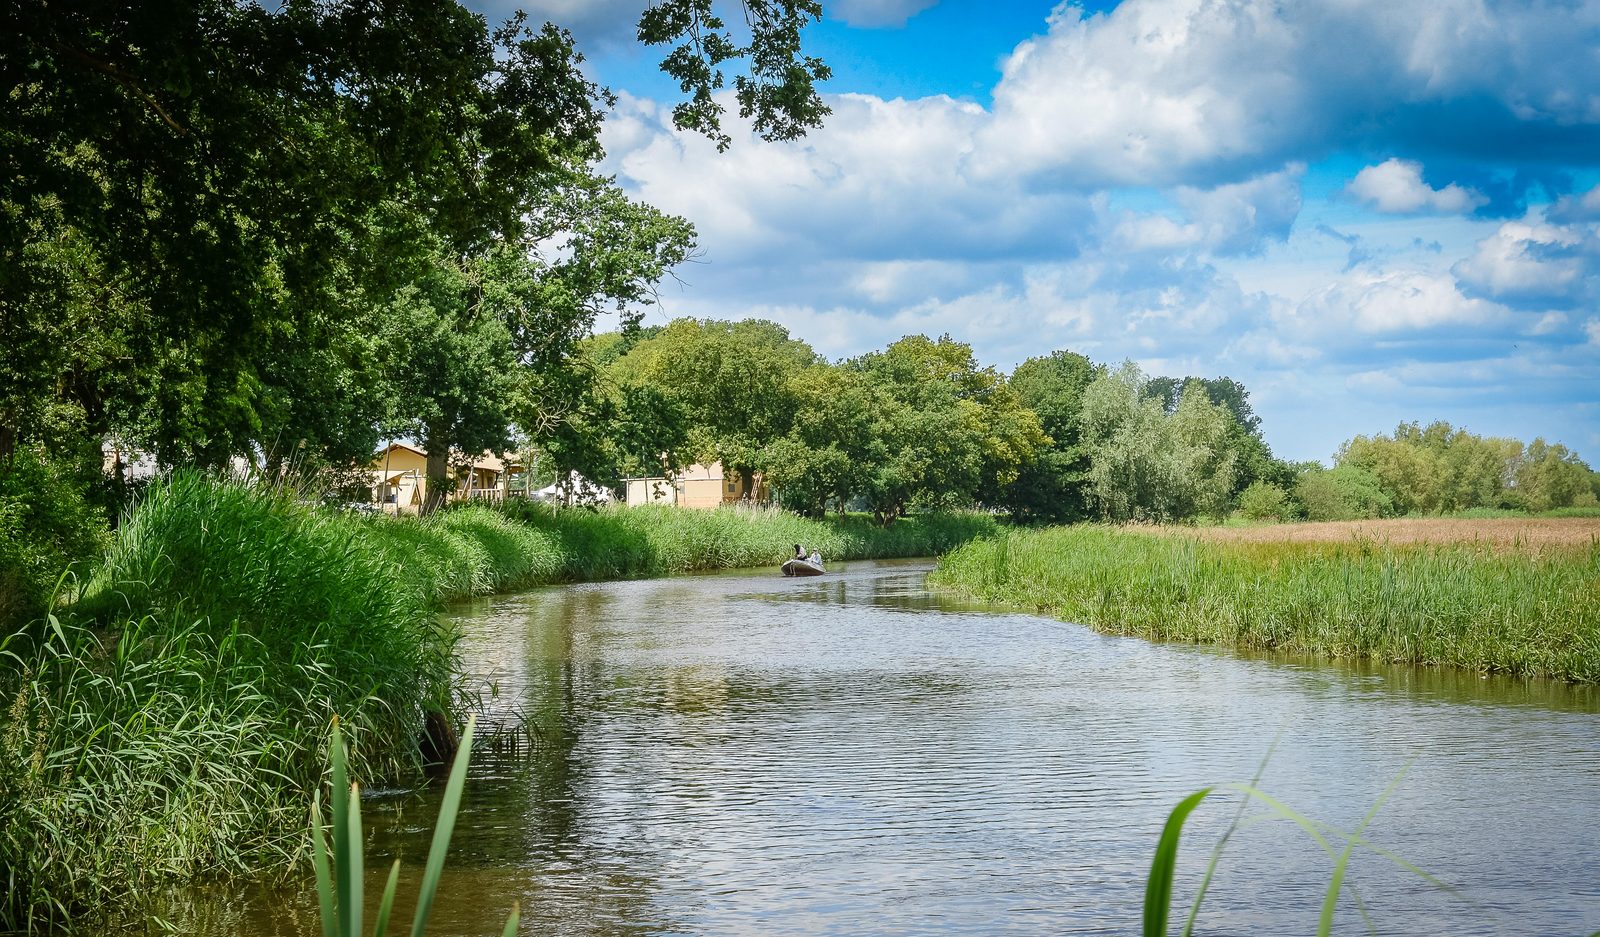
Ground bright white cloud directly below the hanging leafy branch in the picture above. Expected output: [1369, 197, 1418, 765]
[605, 94, 1091, 262]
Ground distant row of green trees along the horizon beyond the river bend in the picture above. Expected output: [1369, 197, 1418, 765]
[521, 318, 1597, 524]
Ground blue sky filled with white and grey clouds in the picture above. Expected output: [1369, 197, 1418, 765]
[469, 0, 1600, 467]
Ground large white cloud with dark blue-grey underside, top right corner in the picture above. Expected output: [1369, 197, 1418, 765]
[976, 0, 1600, 185]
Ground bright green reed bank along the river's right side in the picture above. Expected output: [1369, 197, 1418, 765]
[930, 526, 1600, 683]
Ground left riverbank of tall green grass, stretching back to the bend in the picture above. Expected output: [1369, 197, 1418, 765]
[0, 475, 995, 931]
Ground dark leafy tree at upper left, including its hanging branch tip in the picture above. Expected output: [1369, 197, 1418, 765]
[0, 0, 827, 464]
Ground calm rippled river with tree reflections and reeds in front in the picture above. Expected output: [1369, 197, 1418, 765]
[156, 561, 1600, 937]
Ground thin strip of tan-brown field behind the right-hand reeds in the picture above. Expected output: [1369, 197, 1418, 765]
[1166, 518, 1600, 552]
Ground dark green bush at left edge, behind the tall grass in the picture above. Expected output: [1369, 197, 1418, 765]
[0, 448, 110, 630]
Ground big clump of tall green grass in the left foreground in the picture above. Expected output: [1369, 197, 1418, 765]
[0, 473, 454, 929]
